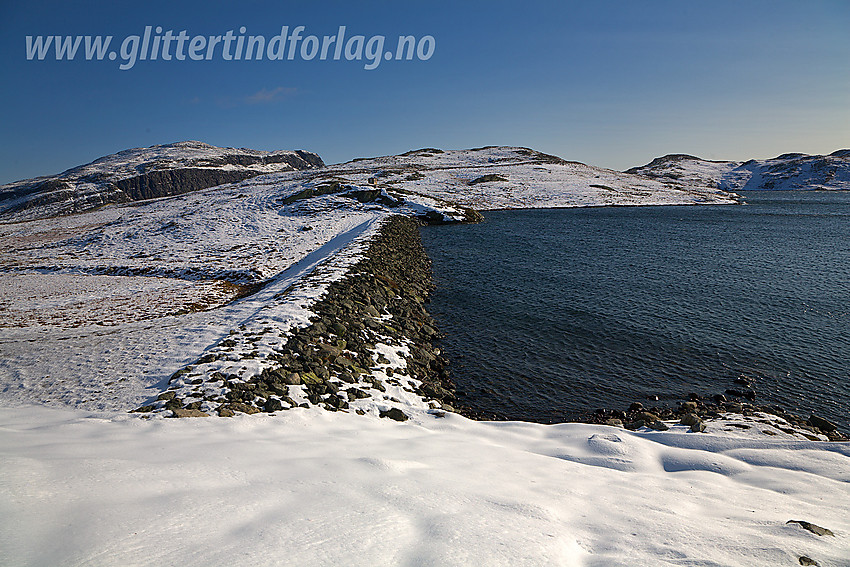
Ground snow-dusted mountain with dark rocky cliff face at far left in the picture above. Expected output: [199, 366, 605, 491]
[0, 141, 324, 221]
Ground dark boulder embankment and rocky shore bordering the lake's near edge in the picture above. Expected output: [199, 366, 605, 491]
[133, 215, 848, 441]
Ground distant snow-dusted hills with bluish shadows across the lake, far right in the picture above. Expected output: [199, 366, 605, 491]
[626, 150, 850, 191]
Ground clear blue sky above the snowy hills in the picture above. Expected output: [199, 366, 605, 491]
[0, 0, 850, 183]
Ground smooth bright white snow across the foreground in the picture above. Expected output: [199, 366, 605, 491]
[0, 407, 850, 567]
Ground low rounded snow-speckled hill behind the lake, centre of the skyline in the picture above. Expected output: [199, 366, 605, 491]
[327, 147, 736, 210]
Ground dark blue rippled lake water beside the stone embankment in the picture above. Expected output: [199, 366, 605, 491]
[422, 192, 850, 431]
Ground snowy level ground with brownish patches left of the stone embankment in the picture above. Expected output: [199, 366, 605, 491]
[0, 180, 386, 410]
